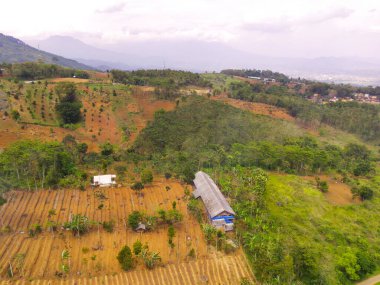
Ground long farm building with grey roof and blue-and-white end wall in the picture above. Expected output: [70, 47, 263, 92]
[193, 171, 235, 231]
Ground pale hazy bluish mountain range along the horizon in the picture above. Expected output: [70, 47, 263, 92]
[25, 36, 380, 85]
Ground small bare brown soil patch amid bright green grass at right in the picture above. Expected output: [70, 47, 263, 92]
[304, 175, 360, 205]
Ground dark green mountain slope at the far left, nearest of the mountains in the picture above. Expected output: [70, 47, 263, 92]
[0, 33, 94, 69]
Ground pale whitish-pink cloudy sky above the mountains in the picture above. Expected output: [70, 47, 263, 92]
[0, 0, 380, 58]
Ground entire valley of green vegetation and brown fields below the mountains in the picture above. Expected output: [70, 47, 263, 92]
[0, 65, 380, 284]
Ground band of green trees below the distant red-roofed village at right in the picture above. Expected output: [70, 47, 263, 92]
[228, 82, 380, 141]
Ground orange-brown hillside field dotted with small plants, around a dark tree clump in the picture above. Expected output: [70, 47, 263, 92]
[0, 78, 175, 151]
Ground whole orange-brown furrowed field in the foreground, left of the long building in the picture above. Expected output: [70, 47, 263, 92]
[0, 182, 254, 284]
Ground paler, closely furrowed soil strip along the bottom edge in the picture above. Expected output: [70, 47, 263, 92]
[0, 255, 252, 285]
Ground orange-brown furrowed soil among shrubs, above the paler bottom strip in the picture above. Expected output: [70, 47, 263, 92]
[0, 181, 254, 284]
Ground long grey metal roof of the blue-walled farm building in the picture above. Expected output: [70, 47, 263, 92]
[193, 171, 236, 218]
